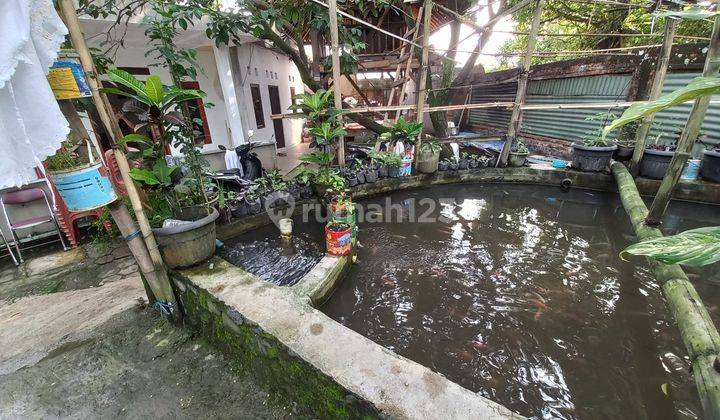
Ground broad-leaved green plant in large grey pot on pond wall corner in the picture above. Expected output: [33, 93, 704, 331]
[105, 69, 219, 268]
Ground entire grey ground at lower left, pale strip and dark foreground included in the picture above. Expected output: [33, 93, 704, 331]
[0, 243, 291, 419]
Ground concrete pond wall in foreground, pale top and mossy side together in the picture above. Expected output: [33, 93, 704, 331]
[172, 258, 521, 419]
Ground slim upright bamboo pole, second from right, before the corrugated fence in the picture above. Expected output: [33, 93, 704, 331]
[630, 18, 678, 174]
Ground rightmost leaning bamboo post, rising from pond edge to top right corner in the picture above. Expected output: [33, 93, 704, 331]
[646, 6, 720, 225]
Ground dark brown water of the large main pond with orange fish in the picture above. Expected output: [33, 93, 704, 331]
[322, 184, 720, 419]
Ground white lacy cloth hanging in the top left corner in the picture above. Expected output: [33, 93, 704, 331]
[0, 0, 70, 188]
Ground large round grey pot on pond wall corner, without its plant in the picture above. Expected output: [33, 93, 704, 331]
[153, 208, 220, 268]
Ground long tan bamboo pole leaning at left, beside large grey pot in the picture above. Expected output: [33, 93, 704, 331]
[59, 0, 181, 320]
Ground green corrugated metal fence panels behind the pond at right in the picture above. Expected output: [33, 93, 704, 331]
[468, 73, 720, 148]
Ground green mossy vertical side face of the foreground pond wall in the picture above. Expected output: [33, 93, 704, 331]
[173, 274, 378, 419]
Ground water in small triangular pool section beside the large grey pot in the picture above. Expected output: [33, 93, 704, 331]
[219, 219, 325, 286]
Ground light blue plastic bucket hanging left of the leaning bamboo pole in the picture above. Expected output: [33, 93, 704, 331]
[48, 163, 117, 212]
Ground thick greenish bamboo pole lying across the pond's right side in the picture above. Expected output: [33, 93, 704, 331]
[610, 162, 720, 418]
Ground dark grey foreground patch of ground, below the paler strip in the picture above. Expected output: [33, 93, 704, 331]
[0, 305, 290, 419]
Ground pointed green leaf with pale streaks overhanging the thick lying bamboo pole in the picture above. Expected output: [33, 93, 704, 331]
[620, 226, 720, 267]
